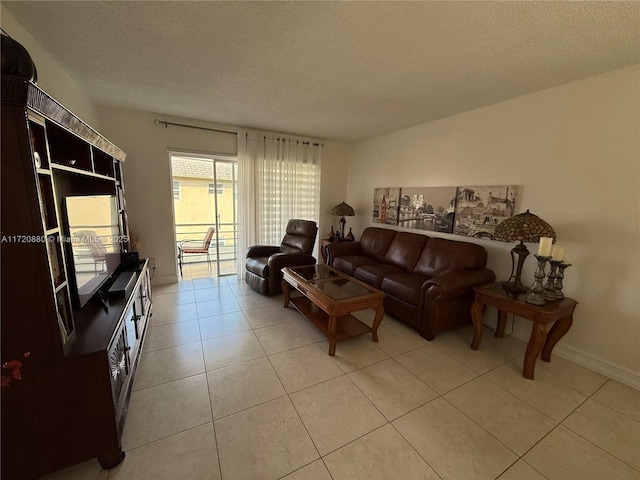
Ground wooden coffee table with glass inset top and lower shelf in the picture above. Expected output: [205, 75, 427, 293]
[282, 264, 384, 356]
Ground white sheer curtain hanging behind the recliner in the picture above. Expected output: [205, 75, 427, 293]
[237, 131, 322, 277]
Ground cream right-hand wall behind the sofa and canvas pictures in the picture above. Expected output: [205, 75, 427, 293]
[347, 65, 640, 386]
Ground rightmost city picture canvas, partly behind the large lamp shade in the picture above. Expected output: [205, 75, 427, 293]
[453, 185, 518, 238]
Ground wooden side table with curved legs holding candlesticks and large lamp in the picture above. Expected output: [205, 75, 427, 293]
[471, 282, 578, 380]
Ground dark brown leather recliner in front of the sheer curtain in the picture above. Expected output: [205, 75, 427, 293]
[245, 219, 318, 295]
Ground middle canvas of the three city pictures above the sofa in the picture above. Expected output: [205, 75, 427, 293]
[398, 187, 456, 233]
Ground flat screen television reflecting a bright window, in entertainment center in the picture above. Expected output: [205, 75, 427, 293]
[63, 195, 121, 308]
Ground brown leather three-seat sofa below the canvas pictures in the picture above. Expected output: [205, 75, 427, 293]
[326, 227, 495, 340]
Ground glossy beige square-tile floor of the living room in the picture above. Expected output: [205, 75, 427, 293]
[42, 270, 640, 480]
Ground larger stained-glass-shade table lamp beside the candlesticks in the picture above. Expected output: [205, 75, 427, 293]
[493, 210, 556, 297]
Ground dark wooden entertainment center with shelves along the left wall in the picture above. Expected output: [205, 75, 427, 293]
[1, 75, 151, 479]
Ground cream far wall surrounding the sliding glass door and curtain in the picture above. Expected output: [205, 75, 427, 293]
[100, 107, 349, 284]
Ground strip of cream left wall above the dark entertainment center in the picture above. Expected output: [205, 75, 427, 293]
[0, 5, 100, 127]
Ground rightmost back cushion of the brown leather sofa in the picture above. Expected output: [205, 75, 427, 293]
[413, 238, 487, 277]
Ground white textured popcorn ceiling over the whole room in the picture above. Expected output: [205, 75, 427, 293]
[3, 1, 640, 141]
